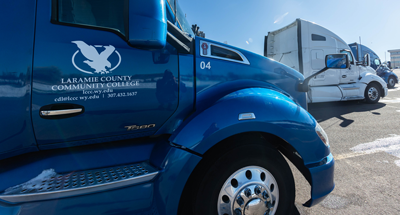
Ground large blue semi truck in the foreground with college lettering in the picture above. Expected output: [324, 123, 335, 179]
[0, 0, 349, 215]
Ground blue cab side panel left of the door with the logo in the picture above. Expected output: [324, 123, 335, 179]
[0, 0, 37, 159]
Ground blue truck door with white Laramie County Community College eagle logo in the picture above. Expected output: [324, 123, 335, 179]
[32, 0, 178, 145]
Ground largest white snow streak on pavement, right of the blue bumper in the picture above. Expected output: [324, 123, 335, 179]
[334, 135, 400, 167]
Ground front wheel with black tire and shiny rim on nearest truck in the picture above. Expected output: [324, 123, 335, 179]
[179, 140, 295, 215]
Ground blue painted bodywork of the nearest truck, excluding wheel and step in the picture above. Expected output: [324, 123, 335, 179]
[0, 0, 334, 212]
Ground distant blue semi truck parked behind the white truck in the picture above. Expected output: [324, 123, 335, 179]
[349, 43, 399, 88]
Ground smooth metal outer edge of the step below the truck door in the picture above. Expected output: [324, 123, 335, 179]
[0, 171, 159, 203]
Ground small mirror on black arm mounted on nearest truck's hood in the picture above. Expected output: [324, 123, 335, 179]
[297, 54, 350, 92]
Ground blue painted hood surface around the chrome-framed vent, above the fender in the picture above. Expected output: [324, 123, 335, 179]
[196, 37, 307, 109]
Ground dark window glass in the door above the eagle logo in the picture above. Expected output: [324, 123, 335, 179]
[58, 0, 127, 35]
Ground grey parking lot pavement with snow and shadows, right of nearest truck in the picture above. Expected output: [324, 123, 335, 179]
[294, 70, 400, 214]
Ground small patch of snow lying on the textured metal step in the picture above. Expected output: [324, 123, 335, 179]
[4, 169, 59, 194]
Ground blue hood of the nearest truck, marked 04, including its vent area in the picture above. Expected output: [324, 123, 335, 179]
[196, 37, 307, 109]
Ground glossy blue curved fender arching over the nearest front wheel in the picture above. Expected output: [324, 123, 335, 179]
[169, 88, 330, 165]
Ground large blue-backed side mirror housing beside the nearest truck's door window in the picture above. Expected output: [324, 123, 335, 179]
[128, 0, 167, 49]
